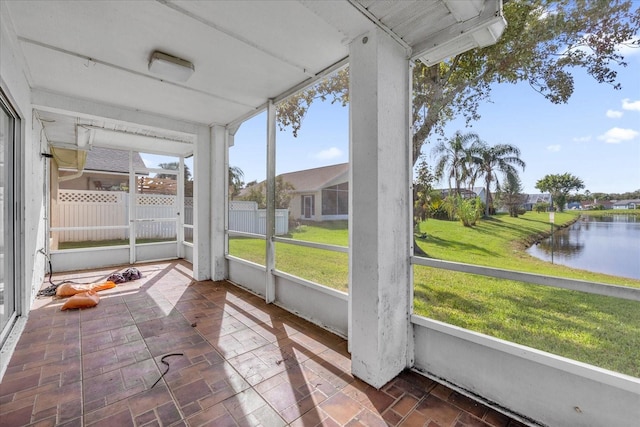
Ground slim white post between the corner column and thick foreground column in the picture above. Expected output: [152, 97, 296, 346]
[265, 100, 276, 303]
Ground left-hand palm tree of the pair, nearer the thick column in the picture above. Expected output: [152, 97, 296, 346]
[431, 131, 481, 195]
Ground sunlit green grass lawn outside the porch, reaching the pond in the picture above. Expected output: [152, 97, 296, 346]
[229, 211, 640, 377]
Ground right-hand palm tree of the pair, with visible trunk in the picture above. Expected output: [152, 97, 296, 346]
[469, 143, 526, 216]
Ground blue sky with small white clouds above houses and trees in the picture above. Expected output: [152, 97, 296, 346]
[229, 42, 640, 193]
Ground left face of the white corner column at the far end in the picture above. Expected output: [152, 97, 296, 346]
[193, 126, 213, 280]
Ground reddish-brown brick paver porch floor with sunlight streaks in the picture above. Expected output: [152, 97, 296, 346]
[0, 261, 522, 427]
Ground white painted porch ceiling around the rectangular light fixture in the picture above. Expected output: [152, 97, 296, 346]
[2, 0, 505, 155]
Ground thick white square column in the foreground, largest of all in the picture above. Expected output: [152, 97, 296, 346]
[349, 25, 412, 388]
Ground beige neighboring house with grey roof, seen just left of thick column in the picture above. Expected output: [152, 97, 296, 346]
[239, 163, 349, 221]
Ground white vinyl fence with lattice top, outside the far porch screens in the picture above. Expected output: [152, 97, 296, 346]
[51, 190, 289, 242]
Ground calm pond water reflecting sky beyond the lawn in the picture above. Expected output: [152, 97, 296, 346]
[527, 214, 640, 279]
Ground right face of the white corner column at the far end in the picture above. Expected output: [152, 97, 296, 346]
[209, 126, 229, 280]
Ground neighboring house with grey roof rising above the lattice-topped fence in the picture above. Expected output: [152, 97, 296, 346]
[58, 147, 148, 191]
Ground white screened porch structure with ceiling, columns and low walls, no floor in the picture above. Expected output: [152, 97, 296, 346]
[0, 0, 640, 425]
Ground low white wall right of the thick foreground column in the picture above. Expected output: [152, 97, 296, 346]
[412, 316, 640, 427]
